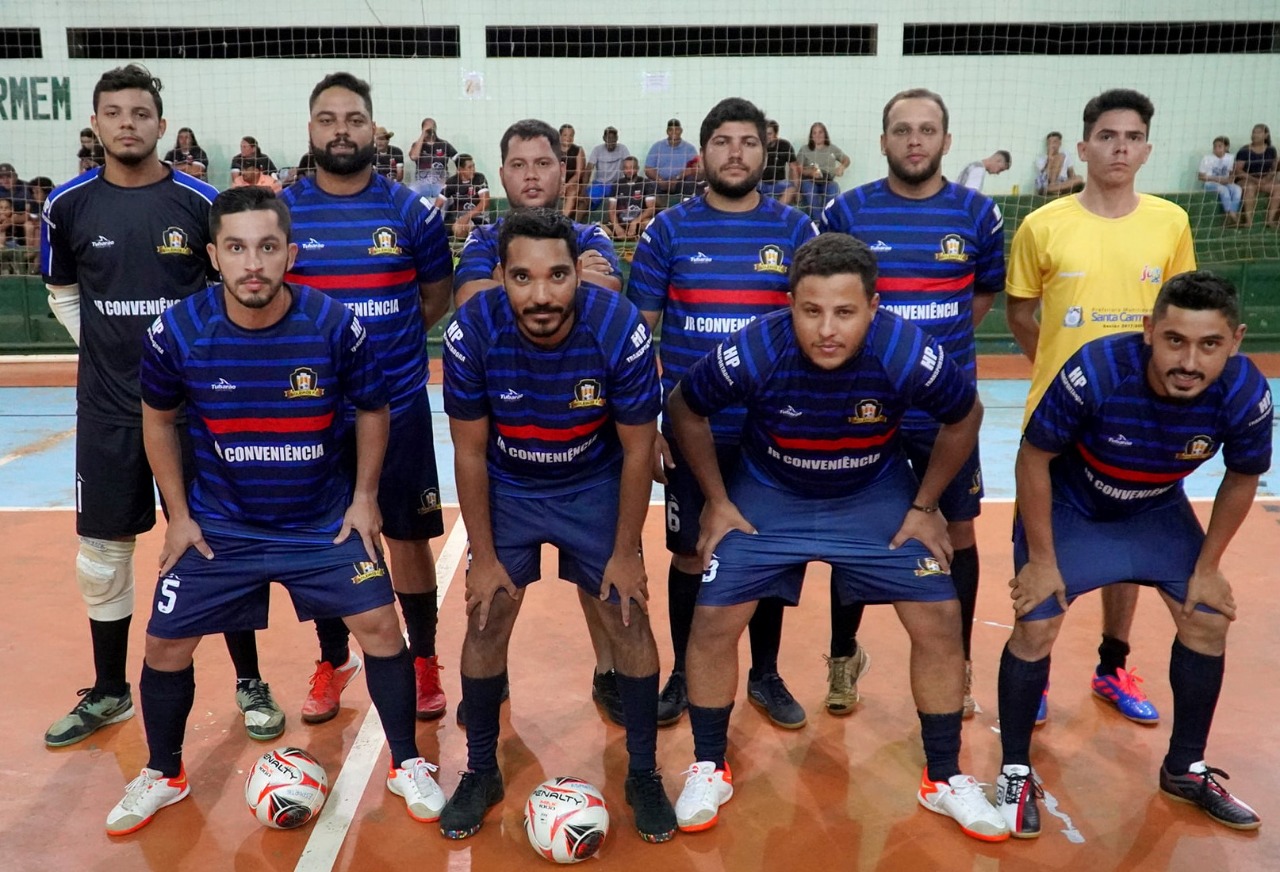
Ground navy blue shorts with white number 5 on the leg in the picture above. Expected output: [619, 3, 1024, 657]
[147, 533, 396, 639]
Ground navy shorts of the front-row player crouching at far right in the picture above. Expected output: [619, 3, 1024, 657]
[1014, 498, 1217, 621]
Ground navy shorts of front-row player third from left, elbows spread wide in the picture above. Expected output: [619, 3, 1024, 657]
[698, 464, 956, 606]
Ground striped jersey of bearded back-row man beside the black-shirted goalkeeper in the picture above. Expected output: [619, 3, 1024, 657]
[280, 173, 453, 414]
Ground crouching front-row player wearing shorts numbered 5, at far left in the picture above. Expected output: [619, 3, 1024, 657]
[106, 188, 444, 835]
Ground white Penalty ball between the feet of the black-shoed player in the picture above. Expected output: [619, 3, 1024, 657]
[525, 777, 609, 863]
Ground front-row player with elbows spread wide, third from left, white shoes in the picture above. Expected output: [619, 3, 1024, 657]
[667, 233, 1009, 841]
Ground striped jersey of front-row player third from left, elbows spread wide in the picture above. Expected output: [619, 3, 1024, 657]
[680, 309, 978, 497]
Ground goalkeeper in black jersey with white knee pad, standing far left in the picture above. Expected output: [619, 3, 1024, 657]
[41, 64, 271, 748]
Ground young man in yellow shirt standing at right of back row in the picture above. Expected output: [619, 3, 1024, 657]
[1005, 88, 1196, 725]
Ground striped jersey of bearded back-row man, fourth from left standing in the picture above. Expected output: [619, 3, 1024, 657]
[627, 197, 818, 444]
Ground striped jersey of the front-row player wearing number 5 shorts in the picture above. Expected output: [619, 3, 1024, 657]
[142, 284, 389, 543]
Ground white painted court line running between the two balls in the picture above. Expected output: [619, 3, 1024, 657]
[293, 515, 467, 872]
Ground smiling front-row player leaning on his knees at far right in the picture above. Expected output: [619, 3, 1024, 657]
[996, 271, 1272, 839]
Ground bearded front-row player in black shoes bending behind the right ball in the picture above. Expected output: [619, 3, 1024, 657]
[440, 209, 676, 841]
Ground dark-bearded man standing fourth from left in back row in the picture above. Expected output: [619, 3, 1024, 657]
[627, 97, 817, 730]
